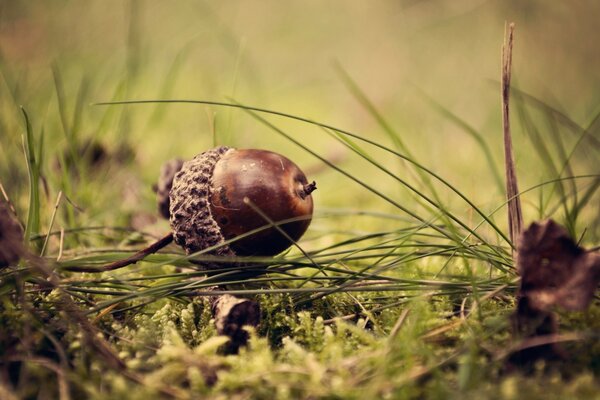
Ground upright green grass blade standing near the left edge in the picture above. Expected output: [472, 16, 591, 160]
[21, 107, 40, 247]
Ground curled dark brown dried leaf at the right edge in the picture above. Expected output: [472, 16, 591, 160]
[517, 220, 600, 311]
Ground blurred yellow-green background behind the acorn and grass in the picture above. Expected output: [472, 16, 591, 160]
[0, 0, 600, 244]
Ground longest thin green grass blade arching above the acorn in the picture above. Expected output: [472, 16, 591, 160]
[94, 99, 512, 250]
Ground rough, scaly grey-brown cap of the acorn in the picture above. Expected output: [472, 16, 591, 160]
[169, 146, 234, 256]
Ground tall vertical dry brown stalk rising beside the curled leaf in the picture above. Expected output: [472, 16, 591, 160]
[502, 23, 523, 257]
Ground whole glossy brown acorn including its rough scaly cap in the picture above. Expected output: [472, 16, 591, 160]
[169, 147, 316, 256]
